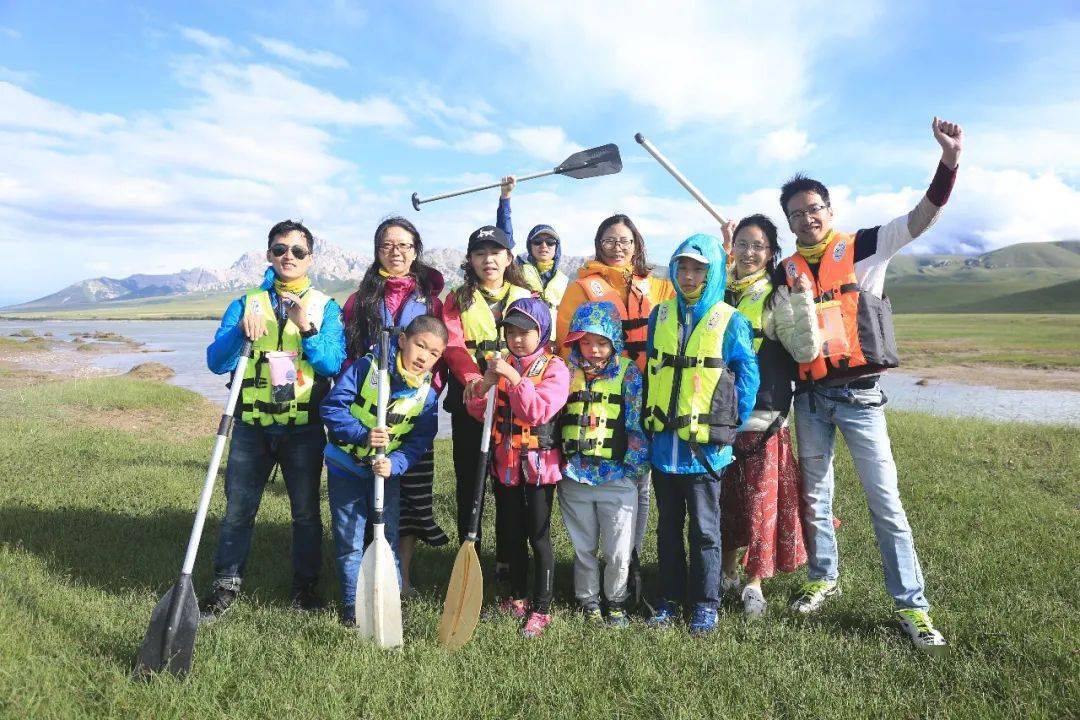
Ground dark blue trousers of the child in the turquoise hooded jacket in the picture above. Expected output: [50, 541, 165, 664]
[652, 467, 720, 610]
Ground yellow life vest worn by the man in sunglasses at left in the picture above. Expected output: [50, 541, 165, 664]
[240, 288, 329, 426]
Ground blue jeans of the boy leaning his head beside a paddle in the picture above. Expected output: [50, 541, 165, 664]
[326, 463, 402, 606]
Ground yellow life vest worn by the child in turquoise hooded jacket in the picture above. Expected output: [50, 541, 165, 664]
[644, 299, 739, 445]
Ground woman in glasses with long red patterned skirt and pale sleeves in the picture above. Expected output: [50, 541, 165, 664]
[720, 215, 821, 617]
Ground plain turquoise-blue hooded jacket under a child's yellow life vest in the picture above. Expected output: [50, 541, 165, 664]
[648, 233, 759, 475]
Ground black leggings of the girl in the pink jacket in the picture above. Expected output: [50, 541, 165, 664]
[491, 481, 555, 613]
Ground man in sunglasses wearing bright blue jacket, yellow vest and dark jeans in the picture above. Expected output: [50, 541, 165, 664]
[200, 220, 346, 619]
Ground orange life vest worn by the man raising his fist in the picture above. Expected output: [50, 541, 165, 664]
[784, 232, 900, 381]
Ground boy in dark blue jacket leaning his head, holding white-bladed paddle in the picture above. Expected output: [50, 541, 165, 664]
[322, 315, 448, 626]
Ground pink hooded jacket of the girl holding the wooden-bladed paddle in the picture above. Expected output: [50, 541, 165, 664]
[465, 298, 570, 487]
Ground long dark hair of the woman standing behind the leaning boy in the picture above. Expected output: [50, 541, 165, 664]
[346, 216, 435, 357]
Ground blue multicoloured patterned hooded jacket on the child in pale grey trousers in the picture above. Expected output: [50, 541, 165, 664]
[563, 302, 649, 486]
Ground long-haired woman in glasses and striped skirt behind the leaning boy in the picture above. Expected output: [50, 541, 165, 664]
[341, 217, 449, 597]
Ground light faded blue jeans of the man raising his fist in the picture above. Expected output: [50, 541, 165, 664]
[795, 385, 930, 610]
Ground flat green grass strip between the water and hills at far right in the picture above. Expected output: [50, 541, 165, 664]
[894, 314, 1080, 369]
